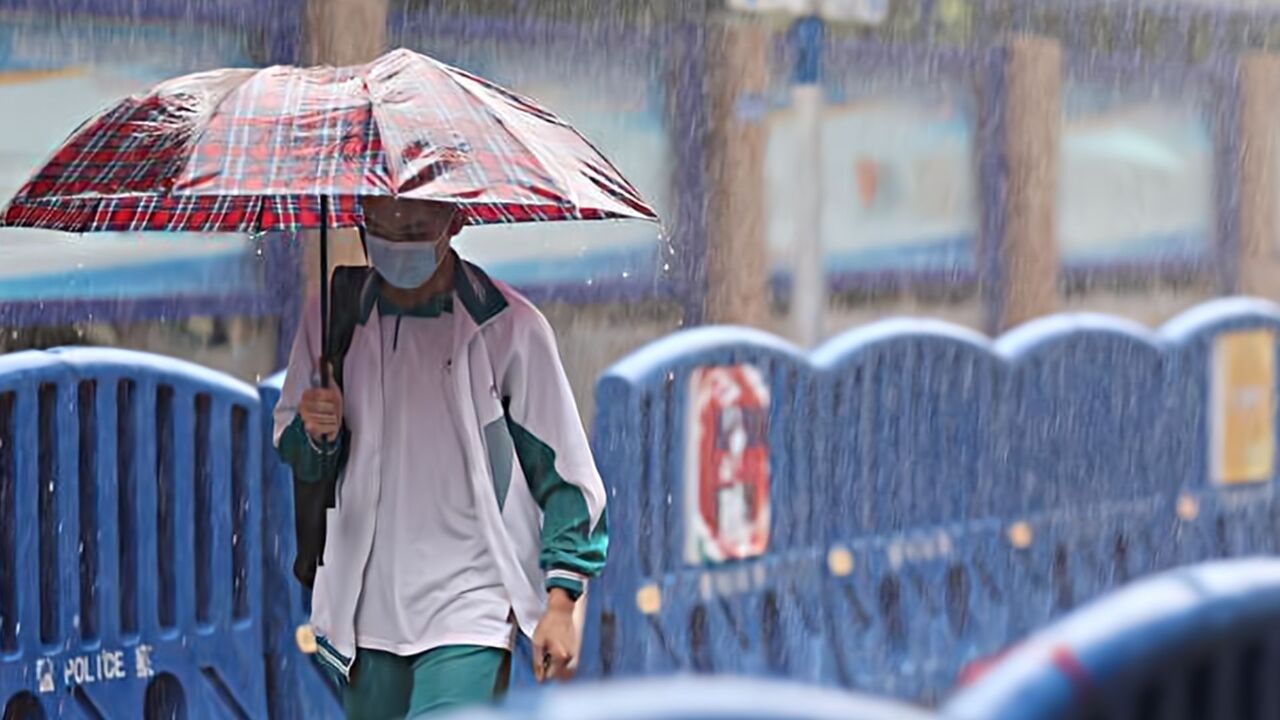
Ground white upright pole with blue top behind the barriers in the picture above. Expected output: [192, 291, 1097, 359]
[790, 15, 827, 347]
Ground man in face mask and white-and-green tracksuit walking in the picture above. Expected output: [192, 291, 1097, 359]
[275, 199, 608, 720]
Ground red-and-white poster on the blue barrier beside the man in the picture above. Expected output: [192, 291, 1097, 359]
[685, 365, 769, 565]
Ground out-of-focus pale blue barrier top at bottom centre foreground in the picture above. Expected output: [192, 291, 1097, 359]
[437, 676, 934, 720]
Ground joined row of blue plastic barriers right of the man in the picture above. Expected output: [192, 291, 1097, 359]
[588, 299, 1280, 701]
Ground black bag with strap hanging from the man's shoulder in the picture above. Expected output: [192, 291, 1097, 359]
[293, 266, 374, 588]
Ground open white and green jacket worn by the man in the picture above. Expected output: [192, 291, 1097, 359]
[274, 261, 608, 675]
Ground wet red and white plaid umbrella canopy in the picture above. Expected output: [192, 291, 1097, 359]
[0, 50, 657, 232]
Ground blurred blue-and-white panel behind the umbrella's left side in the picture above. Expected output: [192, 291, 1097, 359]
[0, 14, 266, 308]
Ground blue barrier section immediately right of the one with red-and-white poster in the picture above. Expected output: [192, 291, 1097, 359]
[813, 320, 1002, 697]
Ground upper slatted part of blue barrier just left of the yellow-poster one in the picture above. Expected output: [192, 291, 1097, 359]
[1000, 315, 1167, 512]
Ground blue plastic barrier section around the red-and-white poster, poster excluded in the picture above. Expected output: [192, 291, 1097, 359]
[582, 328, 822, 679]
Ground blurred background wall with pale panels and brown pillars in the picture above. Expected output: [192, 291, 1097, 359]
[0, 0, 1280, 411]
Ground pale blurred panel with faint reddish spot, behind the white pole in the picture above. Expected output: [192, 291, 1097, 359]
[765, 67, 980, 275]
